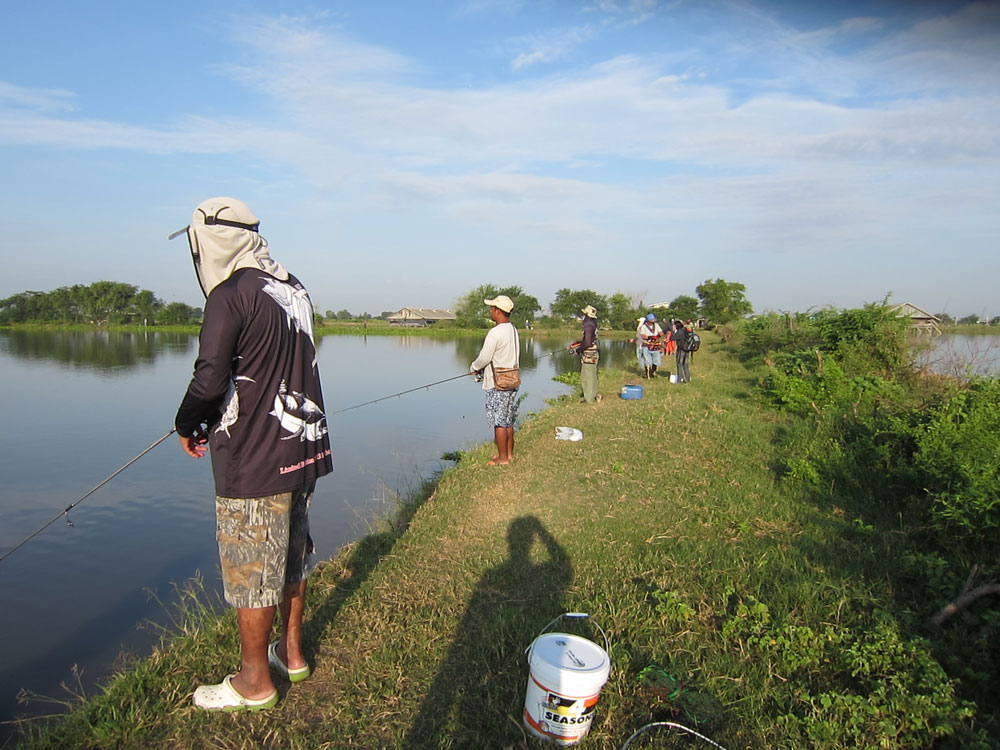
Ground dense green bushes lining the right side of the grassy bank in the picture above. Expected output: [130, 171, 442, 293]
[744, 306, 1000, 748]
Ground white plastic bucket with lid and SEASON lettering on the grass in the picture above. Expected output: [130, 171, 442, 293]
[524, 612, 611, 745]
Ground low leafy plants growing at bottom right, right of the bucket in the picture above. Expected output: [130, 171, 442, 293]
[721, 589, 973, 750]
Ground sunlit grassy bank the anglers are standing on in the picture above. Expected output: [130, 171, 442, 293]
[9, 334, 973, 750]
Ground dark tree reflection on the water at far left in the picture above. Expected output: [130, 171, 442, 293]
[0, 330, 194, 371]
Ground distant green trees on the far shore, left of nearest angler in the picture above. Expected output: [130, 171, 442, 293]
[0, 281, 202, 326]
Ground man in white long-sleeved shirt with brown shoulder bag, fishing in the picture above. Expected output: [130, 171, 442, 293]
[469, 294, 521, 466]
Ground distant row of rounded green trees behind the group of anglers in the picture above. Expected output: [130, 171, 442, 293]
[455, 279, 753, 330]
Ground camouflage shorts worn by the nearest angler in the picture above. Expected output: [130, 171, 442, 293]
[215, 483, 315, 608]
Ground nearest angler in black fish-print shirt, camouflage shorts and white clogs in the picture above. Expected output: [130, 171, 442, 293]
[174, 198, 333, 710]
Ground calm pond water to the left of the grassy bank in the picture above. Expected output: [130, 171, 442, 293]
[0, 331, 634, 742]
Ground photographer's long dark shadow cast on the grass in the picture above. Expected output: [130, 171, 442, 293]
[406, 516, 573, 747]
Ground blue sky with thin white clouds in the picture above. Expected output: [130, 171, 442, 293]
[0, 0, 1000, 317]
